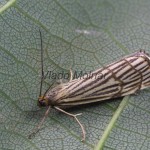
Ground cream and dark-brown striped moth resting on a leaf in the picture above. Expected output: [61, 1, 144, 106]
[28, 32, 150, 141]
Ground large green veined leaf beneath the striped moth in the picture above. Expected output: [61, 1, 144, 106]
[0, 0, 150, 150]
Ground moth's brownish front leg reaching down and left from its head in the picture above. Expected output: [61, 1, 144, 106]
[28, 106, 51, 139]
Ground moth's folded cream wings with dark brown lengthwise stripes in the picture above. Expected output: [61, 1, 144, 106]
[50, 52, 150, 106]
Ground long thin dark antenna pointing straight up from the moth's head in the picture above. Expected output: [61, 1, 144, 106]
[39, 29, 44, 97]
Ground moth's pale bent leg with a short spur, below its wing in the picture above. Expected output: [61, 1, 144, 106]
[54, 106, 86, 141]
